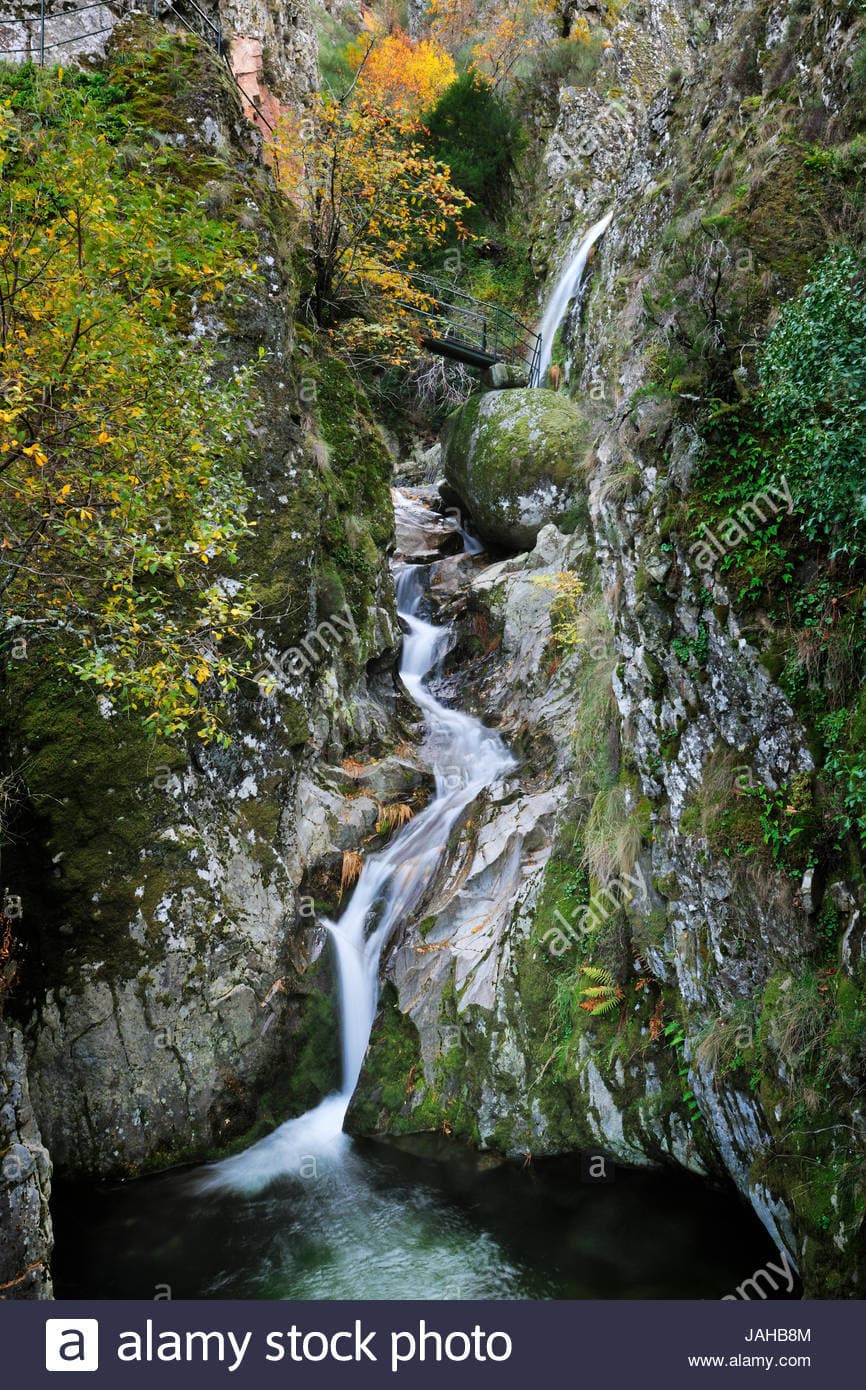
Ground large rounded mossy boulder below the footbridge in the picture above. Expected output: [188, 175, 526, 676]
[443, 388, 592, 550]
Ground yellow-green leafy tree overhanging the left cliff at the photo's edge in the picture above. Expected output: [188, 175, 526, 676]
[0, 72, 252, 738]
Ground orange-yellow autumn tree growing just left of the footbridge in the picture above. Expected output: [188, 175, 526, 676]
[274, 90, 470, 361]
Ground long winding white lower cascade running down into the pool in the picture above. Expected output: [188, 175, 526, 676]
[197, 500, 516, 1193]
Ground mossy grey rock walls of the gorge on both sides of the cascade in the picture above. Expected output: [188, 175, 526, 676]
[0, 0, 866, 1298]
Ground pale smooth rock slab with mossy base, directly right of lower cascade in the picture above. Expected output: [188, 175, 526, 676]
[349, 514, 723, 1173]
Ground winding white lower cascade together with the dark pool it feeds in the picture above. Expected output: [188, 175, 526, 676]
[57, 493, 783, 1300]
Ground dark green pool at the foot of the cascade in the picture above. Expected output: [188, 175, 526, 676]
[56, 1140, 776, 1300]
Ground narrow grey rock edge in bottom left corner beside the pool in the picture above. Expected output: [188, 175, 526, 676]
[0, 1019, 51, 1298]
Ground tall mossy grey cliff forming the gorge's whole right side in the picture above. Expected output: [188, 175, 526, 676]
[353, 3, 866, 1297]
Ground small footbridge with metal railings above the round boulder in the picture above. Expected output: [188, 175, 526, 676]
[405, 275, 541, 386]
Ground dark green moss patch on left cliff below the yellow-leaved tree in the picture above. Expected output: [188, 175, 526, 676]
[4, 659, 195, 979]
